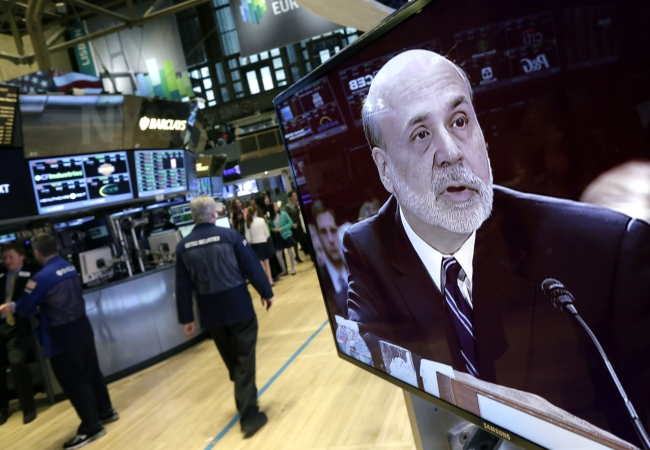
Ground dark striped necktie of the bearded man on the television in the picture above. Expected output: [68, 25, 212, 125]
[442, 257, 479, 377]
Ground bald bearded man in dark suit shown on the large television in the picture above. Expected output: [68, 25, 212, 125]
[344, 50, 650, 440]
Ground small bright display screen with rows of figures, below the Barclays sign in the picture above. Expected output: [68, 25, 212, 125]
[133, 150, 188, 198]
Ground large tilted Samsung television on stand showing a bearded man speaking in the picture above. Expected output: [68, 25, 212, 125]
[274, 0, 650, 450]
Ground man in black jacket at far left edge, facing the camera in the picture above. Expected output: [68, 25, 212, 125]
[0, 242, 39, 425]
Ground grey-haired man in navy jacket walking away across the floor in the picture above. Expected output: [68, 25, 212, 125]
[176, 195, 273, 438]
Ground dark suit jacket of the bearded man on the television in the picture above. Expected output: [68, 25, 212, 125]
[344, 187, 650, 442]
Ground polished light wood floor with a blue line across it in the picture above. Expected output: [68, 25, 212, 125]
[0, 261, 415, 450]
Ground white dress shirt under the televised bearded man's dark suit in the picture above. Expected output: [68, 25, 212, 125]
[399, 207, 476, 308]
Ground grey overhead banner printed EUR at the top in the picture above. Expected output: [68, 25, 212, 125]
[230, 0, 342, 56]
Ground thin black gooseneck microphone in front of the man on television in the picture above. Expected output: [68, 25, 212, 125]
[542, 278, 650, 450]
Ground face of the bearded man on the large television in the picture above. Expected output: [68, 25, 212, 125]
[373, 57, 492, 233]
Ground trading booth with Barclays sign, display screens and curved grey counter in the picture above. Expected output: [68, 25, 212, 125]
[0, 91, 215, 402]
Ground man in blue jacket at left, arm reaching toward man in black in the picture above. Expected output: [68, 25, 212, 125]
[0, 234, 119, 449]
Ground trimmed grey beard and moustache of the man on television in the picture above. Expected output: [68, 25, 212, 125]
[389, 163, 494, 234]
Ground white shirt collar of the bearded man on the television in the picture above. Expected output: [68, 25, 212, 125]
[399, 206, 476, 292]
